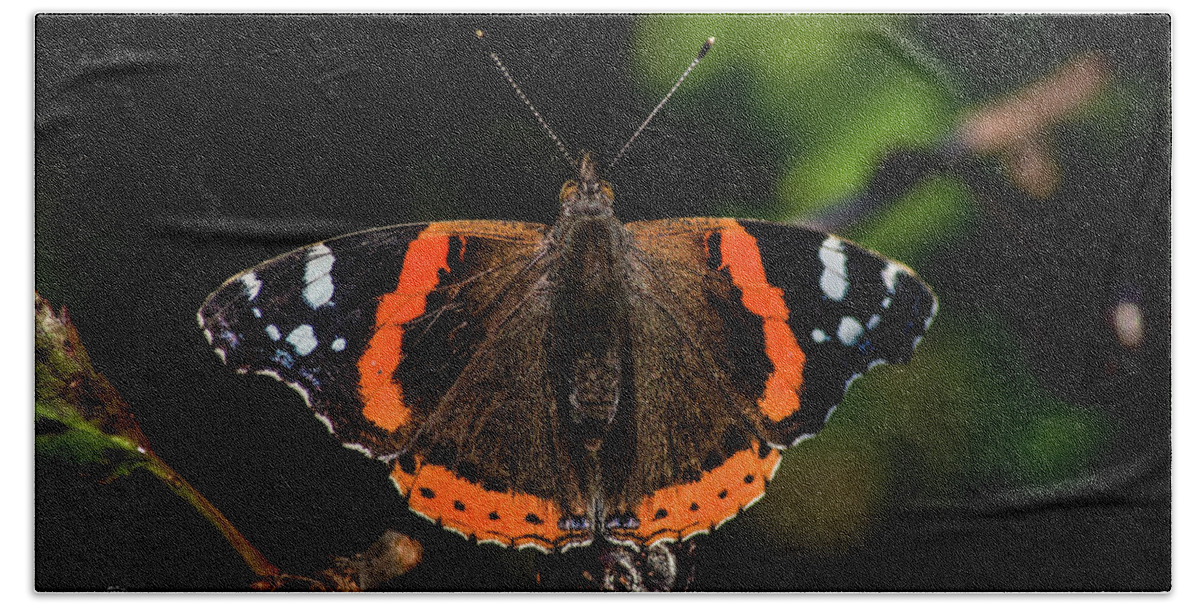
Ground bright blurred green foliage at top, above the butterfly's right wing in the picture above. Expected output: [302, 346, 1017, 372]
[632, 14, 970, 264]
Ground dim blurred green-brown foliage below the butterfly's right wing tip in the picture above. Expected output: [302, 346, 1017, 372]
[750, 312, 1109, 548]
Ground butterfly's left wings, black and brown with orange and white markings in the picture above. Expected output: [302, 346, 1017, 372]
[198, 222, 588, 550]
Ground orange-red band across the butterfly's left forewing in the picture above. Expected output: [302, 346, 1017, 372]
[359, 227, 450, 432]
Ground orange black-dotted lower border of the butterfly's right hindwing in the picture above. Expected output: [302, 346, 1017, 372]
[611, 441, 780, 547]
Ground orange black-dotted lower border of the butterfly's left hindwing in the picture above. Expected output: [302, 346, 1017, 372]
[391, 456, 592, 553]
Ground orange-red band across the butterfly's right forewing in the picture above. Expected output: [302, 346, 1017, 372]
[721, 219, 805, 422]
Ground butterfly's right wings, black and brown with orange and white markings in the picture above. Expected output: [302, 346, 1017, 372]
[607, 218, 936, 544]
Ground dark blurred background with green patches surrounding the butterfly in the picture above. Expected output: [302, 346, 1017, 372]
[35, 16, 1171, 590]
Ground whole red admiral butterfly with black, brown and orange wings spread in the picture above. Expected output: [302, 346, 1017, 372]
[198, 35, 937, 550]
